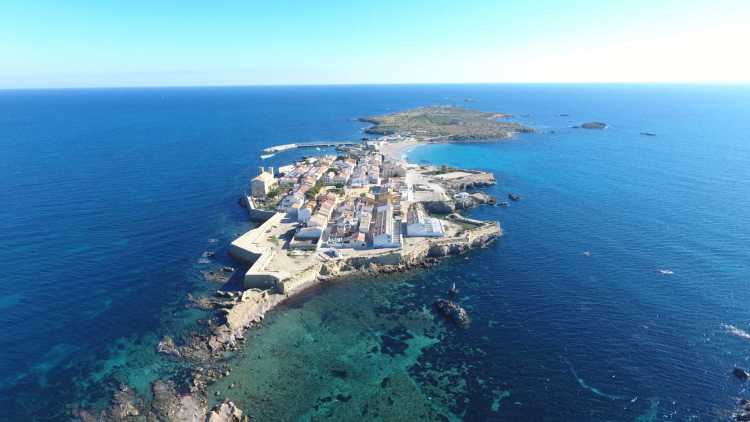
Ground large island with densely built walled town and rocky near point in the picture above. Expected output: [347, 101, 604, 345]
[78, 107, 531, 422]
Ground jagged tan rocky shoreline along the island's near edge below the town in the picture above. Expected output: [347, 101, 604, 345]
[75, 216, 502, 422]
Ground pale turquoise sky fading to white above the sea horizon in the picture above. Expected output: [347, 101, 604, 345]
[0, 0, 750, 88]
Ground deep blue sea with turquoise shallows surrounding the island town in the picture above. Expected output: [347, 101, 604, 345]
[0, 85, 750, 421]
